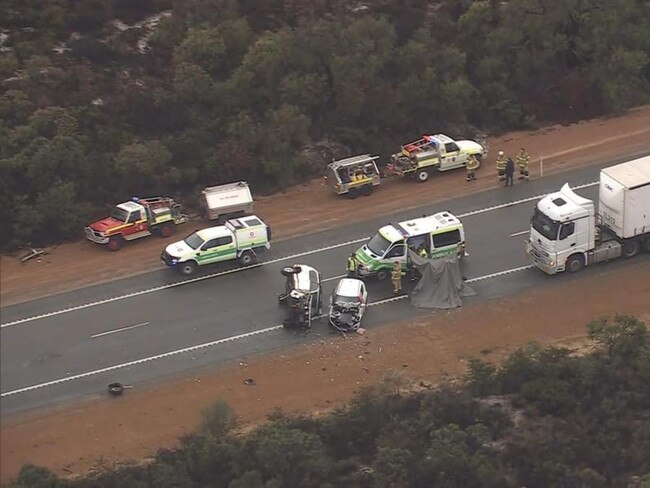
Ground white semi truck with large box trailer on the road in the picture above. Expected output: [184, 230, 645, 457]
[526, 156, 650, 275]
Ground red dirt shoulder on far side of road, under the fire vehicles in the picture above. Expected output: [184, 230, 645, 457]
[0, 106, 650, 306]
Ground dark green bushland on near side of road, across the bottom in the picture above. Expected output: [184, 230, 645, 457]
[9, 316, 650, 488]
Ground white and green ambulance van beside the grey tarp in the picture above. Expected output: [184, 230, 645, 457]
[351, 212, 465, 281]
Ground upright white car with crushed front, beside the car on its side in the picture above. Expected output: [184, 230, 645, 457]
[329, 278, 368, 332]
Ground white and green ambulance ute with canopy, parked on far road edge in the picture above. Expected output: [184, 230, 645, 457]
[160, 215, 271, 275]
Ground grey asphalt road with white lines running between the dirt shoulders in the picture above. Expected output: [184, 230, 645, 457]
[0, 153, 648, 415]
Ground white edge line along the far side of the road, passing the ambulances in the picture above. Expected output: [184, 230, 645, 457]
[0, 181, 598, 328]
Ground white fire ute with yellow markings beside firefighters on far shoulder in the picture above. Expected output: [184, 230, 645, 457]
[387, 134, 487, 182]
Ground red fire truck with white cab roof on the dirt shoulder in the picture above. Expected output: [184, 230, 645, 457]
[84, 197, 187, 251]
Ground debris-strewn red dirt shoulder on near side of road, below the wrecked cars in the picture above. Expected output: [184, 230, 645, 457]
[0, 262, 650, 480]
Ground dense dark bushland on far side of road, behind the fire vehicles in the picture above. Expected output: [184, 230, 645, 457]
[0, 0, 650, 247]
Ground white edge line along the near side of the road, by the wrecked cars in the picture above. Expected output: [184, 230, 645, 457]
[0, 265, 534, 398]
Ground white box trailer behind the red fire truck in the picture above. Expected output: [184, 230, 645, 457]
[201, 181, 253, 222]
